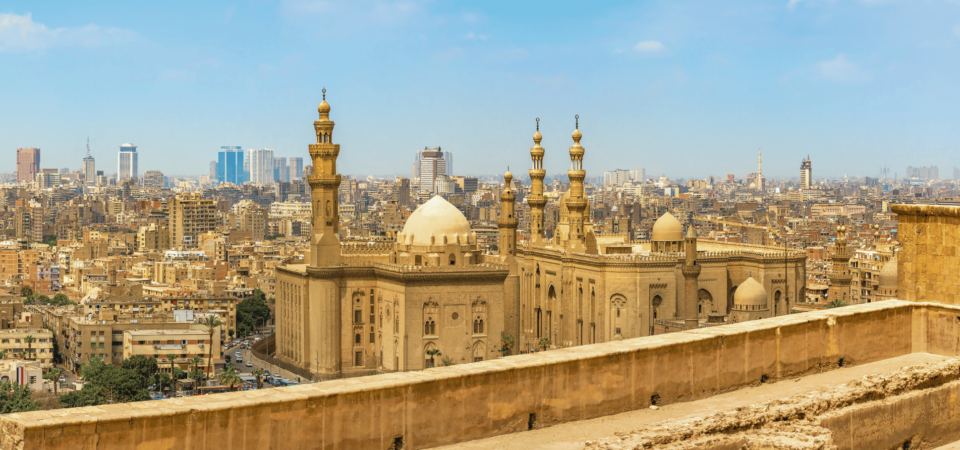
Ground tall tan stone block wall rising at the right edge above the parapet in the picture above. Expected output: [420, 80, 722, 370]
[891, 205, 960, 305]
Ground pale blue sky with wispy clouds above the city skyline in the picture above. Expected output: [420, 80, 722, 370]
[0, 0, 960, 178]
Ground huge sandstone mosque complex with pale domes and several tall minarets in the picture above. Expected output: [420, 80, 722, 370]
[276, 95, 806, 377]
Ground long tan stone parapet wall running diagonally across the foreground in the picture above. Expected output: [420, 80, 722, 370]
[0, 301, 944, 450]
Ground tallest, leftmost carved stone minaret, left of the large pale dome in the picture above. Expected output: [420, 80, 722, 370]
[307, 89, 340, 267]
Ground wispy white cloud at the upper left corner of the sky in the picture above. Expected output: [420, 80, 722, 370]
[0, 13, 137, 52]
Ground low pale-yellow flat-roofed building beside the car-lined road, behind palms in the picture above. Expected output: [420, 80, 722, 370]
[123, 329, 223, 374]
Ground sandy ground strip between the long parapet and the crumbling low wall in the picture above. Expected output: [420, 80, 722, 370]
[436, 353, 948, 450]
